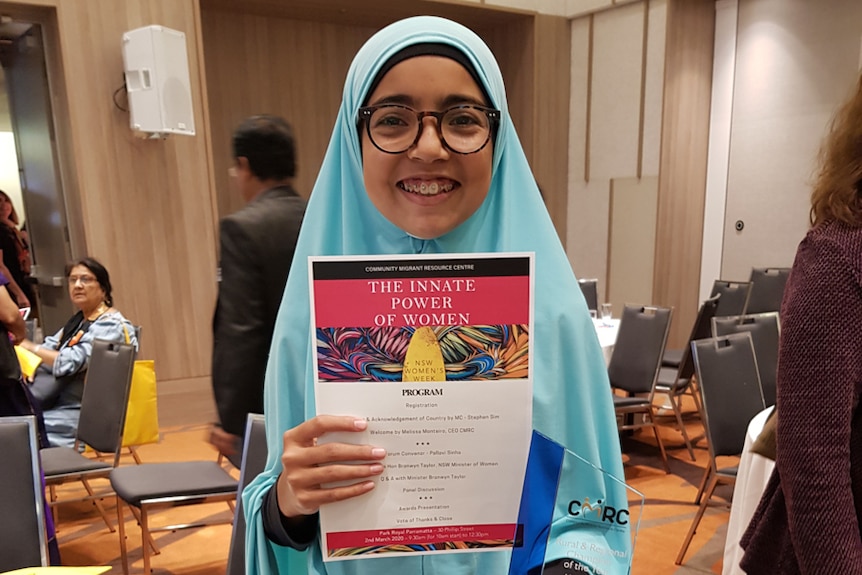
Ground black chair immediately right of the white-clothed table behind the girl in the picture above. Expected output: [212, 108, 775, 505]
[608, 305, 673, 473]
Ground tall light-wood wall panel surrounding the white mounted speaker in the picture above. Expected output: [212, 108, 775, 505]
[5, 0, 215, 389]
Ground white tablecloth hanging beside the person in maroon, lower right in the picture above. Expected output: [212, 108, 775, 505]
[721, 407, 775, 575]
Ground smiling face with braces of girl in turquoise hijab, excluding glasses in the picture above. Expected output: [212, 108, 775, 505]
[360, 56, 494, 239]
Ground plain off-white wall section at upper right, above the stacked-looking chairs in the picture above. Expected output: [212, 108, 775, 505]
[721, 0, 862, 279]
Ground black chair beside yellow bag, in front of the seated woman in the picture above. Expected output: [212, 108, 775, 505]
[40, 339, 135, 532]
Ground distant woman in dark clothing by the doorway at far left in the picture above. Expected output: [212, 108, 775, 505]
[0, 190, 35, 311]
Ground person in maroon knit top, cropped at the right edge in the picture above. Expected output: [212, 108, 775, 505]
[740, 77, 862, 575]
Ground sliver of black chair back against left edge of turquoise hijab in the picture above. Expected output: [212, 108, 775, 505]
[225, 413, 267, 575]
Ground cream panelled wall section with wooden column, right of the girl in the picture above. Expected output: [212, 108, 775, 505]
[566, 0, 715, 346]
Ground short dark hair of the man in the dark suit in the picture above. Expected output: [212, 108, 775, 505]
[232, 114, 296, 180]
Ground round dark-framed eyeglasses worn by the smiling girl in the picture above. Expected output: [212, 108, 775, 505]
[359, 104, 500, 154]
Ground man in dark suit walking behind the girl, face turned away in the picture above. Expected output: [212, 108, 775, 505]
[210, 116, 305, 467]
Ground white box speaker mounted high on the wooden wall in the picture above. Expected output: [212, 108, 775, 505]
[123, 25, 195, 137]
